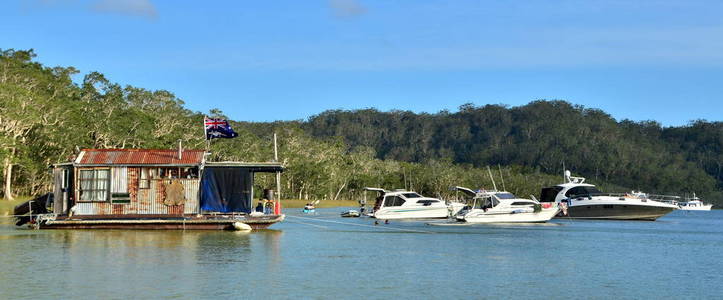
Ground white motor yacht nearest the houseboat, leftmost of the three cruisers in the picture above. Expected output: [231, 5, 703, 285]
[364, 187, 464, 220]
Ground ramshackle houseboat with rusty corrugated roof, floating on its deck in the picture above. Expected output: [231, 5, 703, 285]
[17, 149, 285, 230]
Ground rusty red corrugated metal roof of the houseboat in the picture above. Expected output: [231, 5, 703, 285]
[76, 149, 204, 165]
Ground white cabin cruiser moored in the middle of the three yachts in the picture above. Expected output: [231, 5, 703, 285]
[455, 186, 560, 223]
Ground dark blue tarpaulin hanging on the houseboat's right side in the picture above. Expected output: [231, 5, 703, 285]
[201, 167, 253, 213]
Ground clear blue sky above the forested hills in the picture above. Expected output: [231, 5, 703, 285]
[0, 0, 723, 126]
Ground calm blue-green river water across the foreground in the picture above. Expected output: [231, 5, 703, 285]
[0, 208, 723, 299]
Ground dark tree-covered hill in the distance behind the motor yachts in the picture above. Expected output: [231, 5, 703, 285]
[303, 101, 723, 198]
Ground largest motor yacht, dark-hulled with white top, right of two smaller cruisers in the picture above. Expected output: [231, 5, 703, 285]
[540, 171, 678, 221]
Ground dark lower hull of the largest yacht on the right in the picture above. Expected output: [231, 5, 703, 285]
[558, 204, 675, 221]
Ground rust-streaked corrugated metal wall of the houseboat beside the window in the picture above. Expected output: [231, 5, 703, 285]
[75, 168, 200, 215]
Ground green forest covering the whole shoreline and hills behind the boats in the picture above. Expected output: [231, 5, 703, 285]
[0, 50, 723, 206]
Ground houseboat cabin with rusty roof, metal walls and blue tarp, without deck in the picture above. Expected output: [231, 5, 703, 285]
[53, 149, 283, 219]
